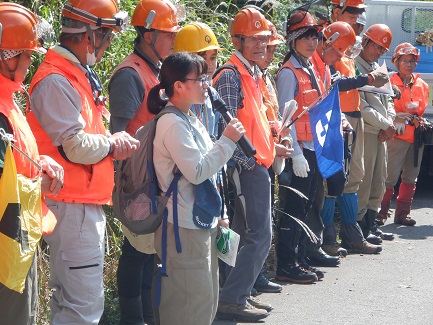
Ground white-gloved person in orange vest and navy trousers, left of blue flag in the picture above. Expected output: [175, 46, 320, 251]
[276, 11, 325, 283]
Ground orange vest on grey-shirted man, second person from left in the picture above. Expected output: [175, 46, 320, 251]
[27, 50, 114, 204]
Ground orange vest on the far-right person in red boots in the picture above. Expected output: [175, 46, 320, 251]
[391, 73, 428, 143]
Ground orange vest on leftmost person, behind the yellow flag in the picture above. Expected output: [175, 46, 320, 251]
[0, 74, 57, 235]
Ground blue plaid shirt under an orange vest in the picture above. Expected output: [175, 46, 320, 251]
[214, 51, 259, 170]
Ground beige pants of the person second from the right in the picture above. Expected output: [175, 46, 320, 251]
[357, 133, 387, 221]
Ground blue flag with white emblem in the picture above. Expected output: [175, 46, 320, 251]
[308, 85, 344, 179]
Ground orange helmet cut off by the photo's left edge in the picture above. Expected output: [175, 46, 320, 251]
[0, 2, 46, 53]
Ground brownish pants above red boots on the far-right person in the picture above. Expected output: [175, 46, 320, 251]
[385, 139, 424, 188]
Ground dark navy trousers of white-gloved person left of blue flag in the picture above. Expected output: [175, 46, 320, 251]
[277, 149, 319, 267]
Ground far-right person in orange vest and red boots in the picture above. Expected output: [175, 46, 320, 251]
[377, 43, 428, 226]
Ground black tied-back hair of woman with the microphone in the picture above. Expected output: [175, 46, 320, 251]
[147, 52, 207, 114]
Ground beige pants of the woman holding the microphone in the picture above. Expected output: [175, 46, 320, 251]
[155, 223, 219, 325]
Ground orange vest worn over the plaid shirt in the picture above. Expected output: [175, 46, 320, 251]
[214, 54, 275, 168]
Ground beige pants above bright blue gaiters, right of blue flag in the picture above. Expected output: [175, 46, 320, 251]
[344, 115, 364, 193]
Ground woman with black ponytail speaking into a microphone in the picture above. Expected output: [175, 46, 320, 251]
[148, 52, 245, 325]
